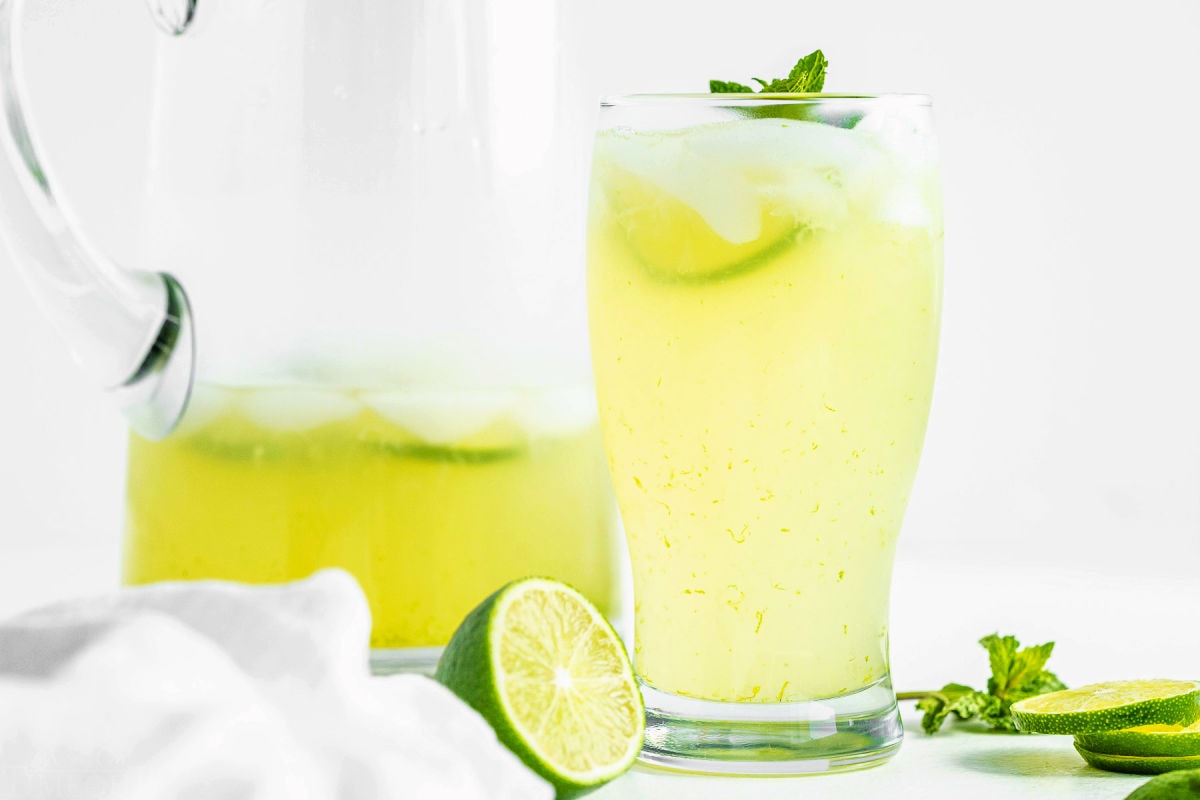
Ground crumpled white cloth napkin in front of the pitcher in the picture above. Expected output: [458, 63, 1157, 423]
[0, 570, 553, 800]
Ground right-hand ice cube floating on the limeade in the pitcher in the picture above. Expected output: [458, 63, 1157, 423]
[362, 389, 521, 446]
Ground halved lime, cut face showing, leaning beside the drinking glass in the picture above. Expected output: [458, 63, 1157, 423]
[434, 578, 646, 799]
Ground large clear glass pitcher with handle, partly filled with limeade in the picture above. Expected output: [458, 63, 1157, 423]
[0, 0, 616, 669]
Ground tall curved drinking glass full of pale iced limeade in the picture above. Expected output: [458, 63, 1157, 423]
[588, 95, 942, 774]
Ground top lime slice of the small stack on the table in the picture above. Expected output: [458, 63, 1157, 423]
[1013, 680, 1200, 734]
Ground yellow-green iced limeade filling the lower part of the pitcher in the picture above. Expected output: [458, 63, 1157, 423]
[125, 386, 614, 662]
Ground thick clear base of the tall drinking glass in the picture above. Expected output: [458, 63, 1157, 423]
[638, 679, 904, 775]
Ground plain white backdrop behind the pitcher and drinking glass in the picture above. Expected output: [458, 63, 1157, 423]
[0, 0, 1200, 601]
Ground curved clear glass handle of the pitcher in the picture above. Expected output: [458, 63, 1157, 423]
[0, 0, 196, 439]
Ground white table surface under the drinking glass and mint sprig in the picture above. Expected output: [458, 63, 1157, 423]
[0, 540, 1200, 800]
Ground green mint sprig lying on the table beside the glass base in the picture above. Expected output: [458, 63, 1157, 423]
[898, 633, 1067, 734]
